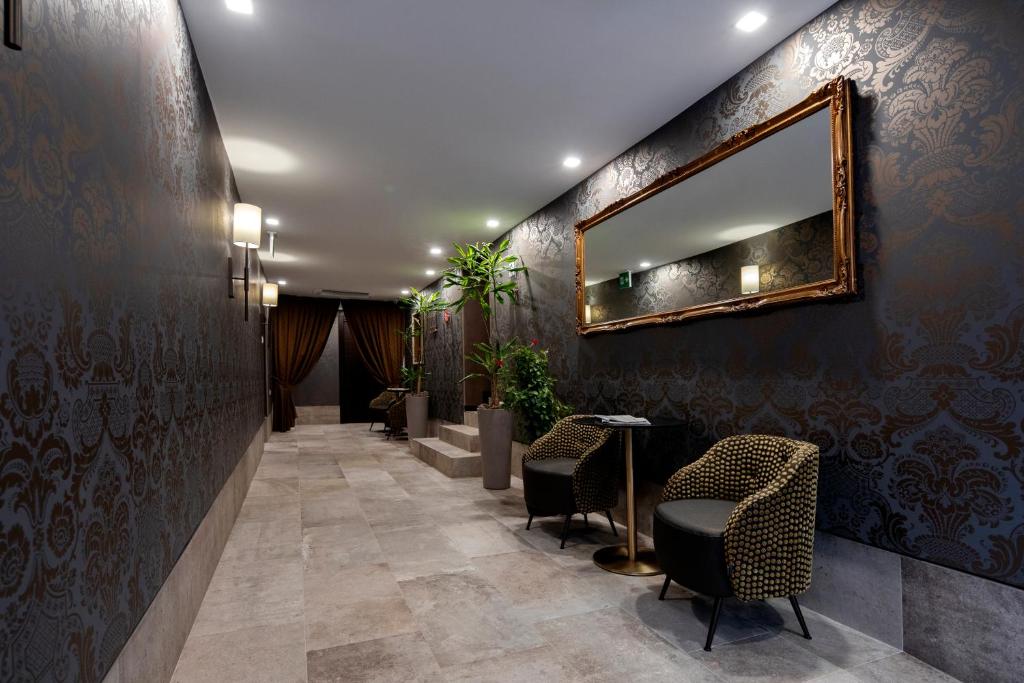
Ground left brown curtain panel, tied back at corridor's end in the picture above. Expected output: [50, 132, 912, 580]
[270, 296, 338, 432]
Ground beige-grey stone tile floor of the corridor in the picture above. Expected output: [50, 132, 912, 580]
[173, 425, 953, 683]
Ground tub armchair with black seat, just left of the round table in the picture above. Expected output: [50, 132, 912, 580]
[522, 415, 618, 548]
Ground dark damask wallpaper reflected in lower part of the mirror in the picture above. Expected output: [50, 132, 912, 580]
[587, 211, 834, 323]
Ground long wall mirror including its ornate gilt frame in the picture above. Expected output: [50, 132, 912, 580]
[577, 79, 855, 334]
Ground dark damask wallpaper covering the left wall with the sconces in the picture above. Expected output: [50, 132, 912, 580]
[0, 0, 263, 681]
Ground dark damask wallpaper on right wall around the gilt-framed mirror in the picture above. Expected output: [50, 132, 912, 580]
[483, 0, 1024, 586]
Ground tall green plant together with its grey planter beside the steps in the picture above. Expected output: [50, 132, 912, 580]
[443, 240, 526, 488]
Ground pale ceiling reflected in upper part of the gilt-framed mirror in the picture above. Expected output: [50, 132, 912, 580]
[584, 109, 833, 284]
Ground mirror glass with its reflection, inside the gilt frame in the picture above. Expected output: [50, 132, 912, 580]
[585, 109, 833, 325]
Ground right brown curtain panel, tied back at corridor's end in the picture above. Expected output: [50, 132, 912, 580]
[341, 299, 406, 387]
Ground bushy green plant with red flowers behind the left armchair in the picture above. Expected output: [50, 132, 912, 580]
[500, 339, 572, 443]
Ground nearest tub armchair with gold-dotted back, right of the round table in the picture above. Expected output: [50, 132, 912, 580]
[654, 435, 818, 650]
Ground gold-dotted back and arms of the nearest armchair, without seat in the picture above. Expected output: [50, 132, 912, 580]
[663, 434, 818, 600]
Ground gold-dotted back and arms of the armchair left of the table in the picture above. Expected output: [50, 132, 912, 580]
[522, 415, 618, 513]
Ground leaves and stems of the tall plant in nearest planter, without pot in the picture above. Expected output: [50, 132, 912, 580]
[442, 240, 526, 408]
